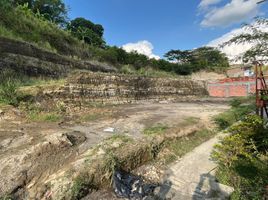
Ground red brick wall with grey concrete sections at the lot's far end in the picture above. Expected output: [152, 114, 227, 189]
[208, 77, 268, 97]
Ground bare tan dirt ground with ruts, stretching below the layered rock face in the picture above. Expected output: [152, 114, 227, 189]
[0, 102, 228, 199]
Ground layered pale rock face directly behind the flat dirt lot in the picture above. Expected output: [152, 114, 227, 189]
[45, 72, 207, 103]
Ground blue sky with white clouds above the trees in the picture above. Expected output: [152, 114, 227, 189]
[64, 0, 268, 59]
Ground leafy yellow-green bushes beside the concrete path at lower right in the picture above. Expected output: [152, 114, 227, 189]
[212, 115, 268, 200]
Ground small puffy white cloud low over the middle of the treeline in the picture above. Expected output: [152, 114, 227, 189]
[122, 40, 160, 60]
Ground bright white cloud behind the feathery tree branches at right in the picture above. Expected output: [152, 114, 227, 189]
[206, 23, 268, 63]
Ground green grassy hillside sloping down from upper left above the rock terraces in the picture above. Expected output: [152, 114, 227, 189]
[0, 2, 187, 77]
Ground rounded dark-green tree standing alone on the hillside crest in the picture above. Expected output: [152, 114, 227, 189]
[67, 18, 105, 47]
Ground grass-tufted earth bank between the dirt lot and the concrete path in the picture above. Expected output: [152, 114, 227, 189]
[66, 124, 218, 197]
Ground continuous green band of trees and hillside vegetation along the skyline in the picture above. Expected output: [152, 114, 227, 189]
[0, 0, 229, 75]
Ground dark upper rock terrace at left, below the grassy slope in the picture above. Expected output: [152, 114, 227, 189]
[0, 37, 117, 78]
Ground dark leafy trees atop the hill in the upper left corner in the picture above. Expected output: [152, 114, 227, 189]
[13, 0, 67, 26]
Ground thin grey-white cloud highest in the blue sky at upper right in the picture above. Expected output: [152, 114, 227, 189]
[200, 0, 259, 27]
